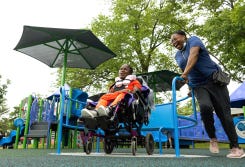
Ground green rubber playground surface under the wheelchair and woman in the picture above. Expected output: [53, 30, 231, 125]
[0, 146, 245, 167]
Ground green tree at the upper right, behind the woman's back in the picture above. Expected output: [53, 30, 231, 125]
[197, 1, 245, 82]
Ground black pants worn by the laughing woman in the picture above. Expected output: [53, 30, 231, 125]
[194, 81, 239, 148]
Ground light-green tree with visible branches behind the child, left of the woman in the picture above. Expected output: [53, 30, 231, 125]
[58, 0, 191, 91]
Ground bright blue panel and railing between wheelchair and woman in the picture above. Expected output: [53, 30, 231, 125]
[142, 76, 197, 157]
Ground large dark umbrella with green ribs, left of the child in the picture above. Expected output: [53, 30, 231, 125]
[14, 26, 116, 86]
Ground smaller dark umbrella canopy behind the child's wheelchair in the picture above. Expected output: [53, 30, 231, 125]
[137, 70, 184, 92]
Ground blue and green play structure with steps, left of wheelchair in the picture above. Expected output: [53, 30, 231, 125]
[11, 86, 88, 148]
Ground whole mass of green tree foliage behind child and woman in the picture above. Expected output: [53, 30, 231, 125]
[58, 0, 245, 95]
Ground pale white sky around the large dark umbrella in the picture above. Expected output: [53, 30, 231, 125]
[0, 0, 241, 110]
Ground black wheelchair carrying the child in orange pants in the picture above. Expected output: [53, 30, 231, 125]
[80, 78, 154, 155]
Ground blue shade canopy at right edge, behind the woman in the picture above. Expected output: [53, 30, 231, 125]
[230, 81, 245, 108]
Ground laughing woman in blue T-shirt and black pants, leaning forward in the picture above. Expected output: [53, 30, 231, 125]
[171, 30, 245, 158]
